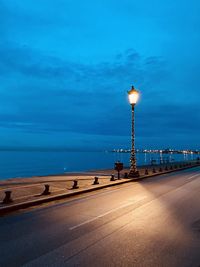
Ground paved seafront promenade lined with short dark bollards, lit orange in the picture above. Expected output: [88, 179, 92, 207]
[0, 160, 200, 215]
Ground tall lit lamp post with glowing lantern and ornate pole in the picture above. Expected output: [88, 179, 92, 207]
[128, 86, 139, 178]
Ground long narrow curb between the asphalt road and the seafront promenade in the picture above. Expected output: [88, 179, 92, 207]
[0, 164, 199, 216]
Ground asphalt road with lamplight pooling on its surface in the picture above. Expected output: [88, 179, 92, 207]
[0, 168, 200, 267]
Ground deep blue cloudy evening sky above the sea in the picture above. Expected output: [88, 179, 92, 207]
[0, 0, 200, 149]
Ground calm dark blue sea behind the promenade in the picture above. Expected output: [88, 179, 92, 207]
[0, 150, 198, 180]
